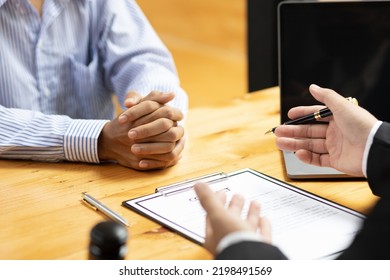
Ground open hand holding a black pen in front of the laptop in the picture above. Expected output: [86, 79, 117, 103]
[275, 85, 380, 177]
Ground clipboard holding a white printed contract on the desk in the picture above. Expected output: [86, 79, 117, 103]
[122, 168, 365, 259]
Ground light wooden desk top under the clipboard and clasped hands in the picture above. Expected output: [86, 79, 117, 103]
[0, 88, 375, 259]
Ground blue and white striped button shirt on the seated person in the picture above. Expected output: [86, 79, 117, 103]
[0, 0, 187, 163]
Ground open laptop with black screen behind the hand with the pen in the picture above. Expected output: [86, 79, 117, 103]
[278, 1, 390, 179]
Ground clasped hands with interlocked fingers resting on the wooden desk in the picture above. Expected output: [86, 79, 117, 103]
[98, 91, 185, 170]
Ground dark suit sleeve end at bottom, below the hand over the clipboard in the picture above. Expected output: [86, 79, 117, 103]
[216, 241, 287, 260]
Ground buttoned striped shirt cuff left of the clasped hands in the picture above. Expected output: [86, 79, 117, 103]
[64, 120, 108, 163]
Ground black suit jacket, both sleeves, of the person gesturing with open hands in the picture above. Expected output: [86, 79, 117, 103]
[216, 123, 390, 260]
